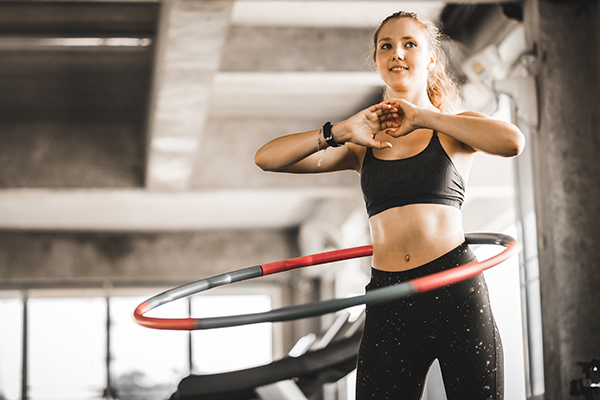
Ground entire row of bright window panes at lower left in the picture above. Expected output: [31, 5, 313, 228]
[0, 289, 273, 400]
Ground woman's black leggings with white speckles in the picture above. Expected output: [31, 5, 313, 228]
[356, 243, 504, 400]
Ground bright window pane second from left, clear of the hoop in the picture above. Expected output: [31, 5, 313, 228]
[27, 297, 106, 400]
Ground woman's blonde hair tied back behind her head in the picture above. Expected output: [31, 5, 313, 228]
[373, 11, 460, 111]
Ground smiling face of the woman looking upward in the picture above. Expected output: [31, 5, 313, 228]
[375, 18, 435, 92]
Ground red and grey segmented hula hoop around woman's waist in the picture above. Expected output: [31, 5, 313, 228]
[133, 233, 519, 331]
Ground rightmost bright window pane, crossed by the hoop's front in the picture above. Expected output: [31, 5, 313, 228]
[192, 295, 273, 374]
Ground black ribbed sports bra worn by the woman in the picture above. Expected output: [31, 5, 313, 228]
[360, 131, 465, 217]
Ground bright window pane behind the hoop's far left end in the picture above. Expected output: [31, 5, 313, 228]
[110, 296, 189, 400]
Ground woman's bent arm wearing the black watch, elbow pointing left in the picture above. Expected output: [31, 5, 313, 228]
[254, 103, 391, 173]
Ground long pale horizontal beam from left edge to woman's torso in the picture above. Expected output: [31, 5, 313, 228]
[0, 187, 359, 231]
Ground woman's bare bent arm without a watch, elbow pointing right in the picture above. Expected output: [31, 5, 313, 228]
[386, 99, 525, 157]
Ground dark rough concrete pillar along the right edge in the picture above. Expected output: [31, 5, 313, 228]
[524, 0, 600, 400]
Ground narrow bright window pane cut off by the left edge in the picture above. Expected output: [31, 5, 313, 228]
[0, 299, 23, 400]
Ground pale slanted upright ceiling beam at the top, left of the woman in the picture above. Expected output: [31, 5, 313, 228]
[146, 0, 233, 190]
